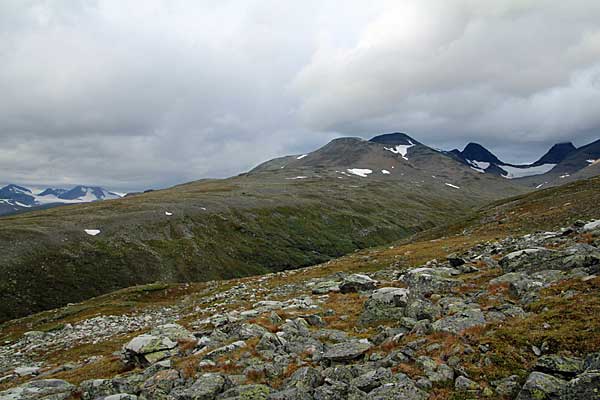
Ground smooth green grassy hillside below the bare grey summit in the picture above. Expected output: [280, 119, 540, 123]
[0, 169, 520, 321]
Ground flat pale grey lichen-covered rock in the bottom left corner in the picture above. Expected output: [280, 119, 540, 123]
[0, 379, 75, 400]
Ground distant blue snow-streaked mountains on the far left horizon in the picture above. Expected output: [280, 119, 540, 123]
[0, 184, 122, 215]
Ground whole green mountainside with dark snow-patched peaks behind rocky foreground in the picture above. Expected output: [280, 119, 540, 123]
[0, 133, 600, 320]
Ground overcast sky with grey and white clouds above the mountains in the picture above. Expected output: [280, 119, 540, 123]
[0, 0, 600, 190]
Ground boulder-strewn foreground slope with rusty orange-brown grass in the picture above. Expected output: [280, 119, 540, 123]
[0, 179, 600, 400]
